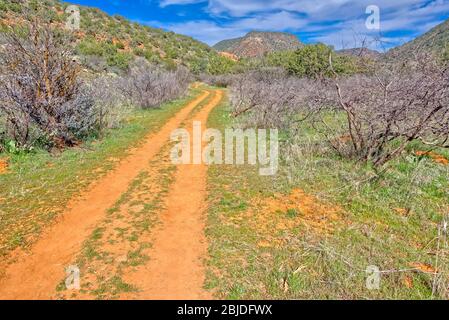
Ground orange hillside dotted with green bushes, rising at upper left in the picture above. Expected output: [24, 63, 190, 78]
[0, 0, 221, 72]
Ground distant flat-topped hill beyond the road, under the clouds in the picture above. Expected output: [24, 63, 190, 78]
[214, 31, 303, 58]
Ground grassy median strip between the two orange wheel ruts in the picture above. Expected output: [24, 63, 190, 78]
[56, 144, 176, 300]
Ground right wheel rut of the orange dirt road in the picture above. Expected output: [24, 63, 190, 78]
[125, 90, 223, 300]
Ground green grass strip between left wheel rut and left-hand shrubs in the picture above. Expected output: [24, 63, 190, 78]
[0, 90, 200, 255]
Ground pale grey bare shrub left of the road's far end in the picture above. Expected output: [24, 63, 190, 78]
[118, 59, 190, 109]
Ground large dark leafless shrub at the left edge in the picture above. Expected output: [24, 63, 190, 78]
[0, 23, 87, 146]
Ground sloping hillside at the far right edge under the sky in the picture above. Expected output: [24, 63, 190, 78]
[387, 20, 449, 58]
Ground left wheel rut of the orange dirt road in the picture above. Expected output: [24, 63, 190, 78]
[0, 92, 210, 300]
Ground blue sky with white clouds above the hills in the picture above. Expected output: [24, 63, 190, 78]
[70, 0, 449, 49]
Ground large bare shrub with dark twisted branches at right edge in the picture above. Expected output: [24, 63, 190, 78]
[331, 54, 449, 167]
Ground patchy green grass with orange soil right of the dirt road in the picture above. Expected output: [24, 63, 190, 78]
[207, 91, 449, 299]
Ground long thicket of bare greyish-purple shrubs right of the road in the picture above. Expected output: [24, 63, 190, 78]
[231, 55, 449, 167]
